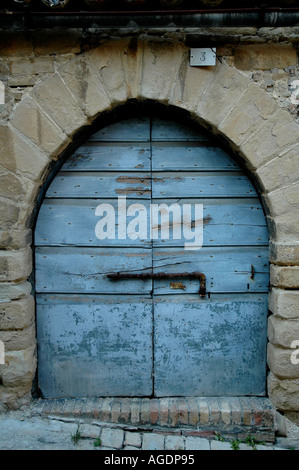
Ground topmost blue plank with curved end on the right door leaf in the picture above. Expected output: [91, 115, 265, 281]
[151, 117, 208, 142]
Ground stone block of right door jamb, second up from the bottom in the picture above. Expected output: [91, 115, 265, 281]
[268, 344, 299, 379]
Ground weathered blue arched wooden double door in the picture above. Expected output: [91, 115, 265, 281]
[35, 117, 268, 397]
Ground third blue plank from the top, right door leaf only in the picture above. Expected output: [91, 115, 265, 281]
[152, 172, 256, 198]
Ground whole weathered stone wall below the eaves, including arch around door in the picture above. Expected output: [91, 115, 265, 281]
[0, 30, 299, 430]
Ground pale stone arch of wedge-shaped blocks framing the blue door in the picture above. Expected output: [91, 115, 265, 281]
[0, 38, 299, 409]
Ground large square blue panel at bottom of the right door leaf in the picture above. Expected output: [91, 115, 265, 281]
[154, 294, 268, 397]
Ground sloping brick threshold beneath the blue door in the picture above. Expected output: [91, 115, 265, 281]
[32, 397, 276, 442]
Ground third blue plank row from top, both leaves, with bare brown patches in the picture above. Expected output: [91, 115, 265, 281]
[46, 171, 256, 198]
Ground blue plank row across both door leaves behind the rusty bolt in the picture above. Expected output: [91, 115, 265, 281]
[36, 247, 269, 294]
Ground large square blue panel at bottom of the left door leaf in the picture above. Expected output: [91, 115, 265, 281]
[37, 294, 152, 398]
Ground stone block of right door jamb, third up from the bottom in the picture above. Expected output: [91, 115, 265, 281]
[268, 312, 299, 346]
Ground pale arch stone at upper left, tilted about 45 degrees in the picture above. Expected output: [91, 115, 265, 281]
[11, 95, 70, 155]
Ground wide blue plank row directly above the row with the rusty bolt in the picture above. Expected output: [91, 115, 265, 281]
[35, 199, 268, 246]
